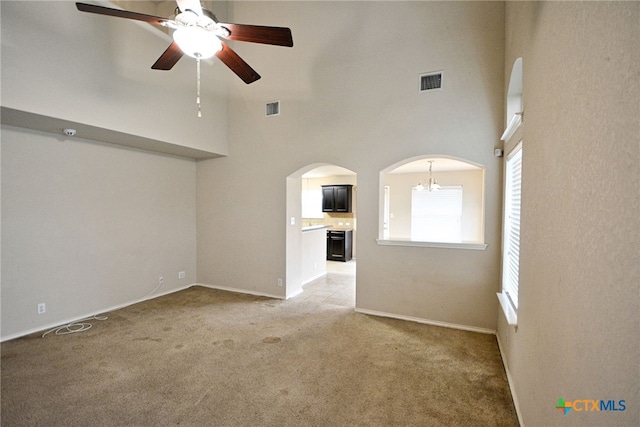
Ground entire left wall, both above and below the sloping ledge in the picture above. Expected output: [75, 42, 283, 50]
[0, 1, 220, 339]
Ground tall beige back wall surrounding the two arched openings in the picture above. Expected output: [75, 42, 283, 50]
[198, 2, 504, 330]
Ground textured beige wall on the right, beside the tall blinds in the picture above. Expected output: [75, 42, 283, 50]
[498, 2, 640, 426]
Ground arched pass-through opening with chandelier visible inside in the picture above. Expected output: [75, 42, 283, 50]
[378, 155, 486, 249]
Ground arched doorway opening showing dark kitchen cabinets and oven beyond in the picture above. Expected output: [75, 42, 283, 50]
[286, 163, 357, 307]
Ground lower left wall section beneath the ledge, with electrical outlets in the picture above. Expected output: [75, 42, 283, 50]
[1, 126, 196, 339]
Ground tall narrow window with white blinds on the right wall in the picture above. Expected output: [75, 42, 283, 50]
[502, 145, 522, 309]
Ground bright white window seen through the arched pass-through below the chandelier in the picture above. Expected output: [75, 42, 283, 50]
[411, 186, 462, 243]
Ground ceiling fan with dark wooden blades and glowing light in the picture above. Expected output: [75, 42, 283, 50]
[76, 0, 293, 84]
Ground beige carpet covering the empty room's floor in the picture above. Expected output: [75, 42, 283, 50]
[1, 287, 518, 427]
